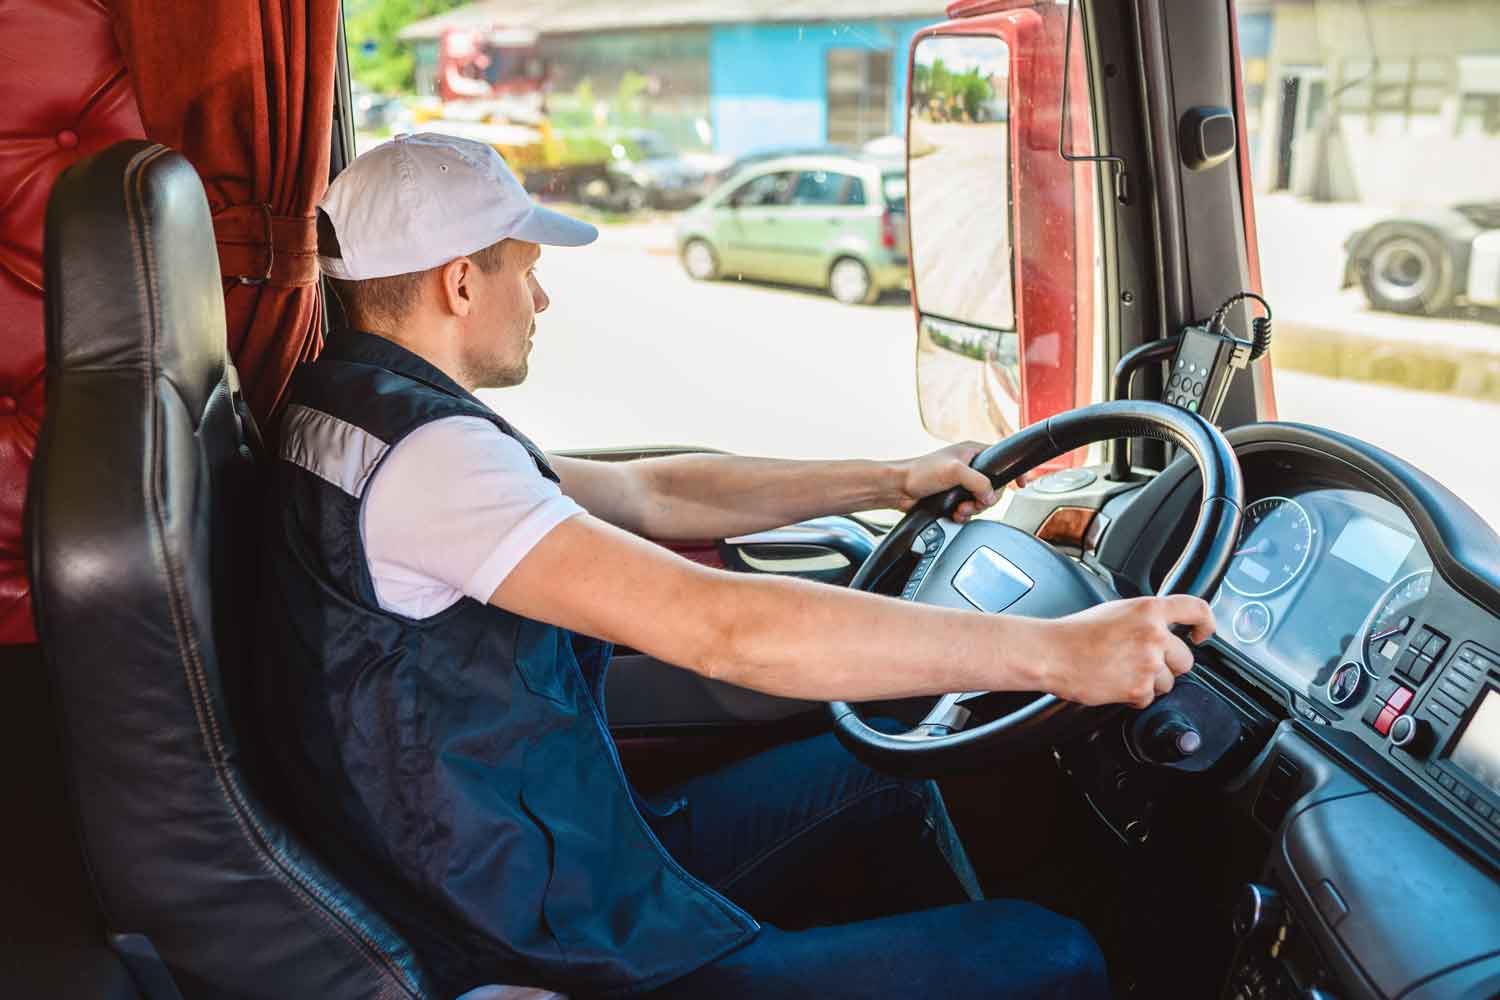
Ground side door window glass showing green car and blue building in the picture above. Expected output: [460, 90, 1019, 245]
[347, 0, 1091, 476]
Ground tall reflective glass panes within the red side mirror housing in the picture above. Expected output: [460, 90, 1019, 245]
[906, 34, 1022, 442]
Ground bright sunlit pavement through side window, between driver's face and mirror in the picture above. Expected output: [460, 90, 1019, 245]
[486, 228, 938, 457]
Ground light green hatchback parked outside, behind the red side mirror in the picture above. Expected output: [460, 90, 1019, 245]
[677, 156, 909, 303]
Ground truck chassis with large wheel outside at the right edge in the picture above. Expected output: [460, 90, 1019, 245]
[1343, 201, 1500, 315]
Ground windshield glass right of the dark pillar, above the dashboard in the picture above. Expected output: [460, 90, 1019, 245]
[1239, 0, 1500, 526]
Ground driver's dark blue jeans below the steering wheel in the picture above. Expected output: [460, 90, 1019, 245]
[636, 735, 1109, 1000]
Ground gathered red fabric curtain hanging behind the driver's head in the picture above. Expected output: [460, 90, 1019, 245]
[114, 0, 339, 421]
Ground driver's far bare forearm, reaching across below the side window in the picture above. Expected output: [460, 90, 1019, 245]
[632, 454, 903, 541]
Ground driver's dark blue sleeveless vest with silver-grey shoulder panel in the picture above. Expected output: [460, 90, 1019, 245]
[258, 333, 758, 996]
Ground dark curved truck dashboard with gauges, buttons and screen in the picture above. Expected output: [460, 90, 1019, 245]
[1085, 424, 1500, 1000]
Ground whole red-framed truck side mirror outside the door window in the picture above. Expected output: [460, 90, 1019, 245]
[906, 9, 1095, 455]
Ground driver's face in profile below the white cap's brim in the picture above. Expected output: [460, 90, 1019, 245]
[465, 240, 551, 388]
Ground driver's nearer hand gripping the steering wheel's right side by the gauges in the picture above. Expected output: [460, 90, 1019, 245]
[1038, 594, 1215, 708]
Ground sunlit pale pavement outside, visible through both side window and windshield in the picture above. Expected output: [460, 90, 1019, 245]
[485, 218, 1500, 526]
